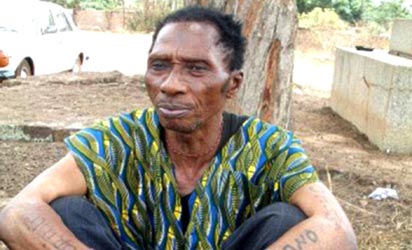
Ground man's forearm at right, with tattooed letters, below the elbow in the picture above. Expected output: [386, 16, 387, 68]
[268, 217, 357, 250]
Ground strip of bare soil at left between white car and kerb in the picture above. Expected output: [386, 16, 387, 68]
[0, 71, 148, 127]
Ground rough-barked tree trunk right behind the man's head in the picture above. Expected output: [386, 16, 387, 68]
[185, 0, 297, 128]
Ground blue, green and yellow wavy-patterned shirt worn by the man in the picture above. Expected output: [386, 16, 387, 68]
[65, 109, 318, 249]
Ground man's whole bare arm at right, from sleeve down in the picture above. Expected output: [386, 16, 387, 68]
[269, 182, 357, 250]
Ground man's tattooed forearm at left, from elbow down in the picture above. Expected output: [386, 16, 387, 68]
[0, 200, 89, 250]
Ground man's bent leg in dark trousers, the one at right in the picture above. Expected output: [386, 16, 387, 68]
[222, 202, 306, 250]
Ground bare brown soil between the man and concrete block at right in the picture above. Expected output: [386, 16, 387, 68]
[293, 95, 412, 250]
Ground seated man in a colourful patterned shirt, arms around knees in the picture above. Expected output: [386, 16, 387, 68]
[0, 7, 356, 250]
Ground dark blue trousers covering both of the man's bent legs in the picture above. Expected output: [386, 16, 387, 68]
[51, 196, 306, 250]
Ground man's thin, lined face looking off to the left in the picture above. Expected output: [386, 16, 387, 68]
[145, 22, 239, 133]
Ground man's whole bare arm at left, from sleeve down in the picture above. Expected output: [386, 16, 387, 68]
[0, 154, 88, 250]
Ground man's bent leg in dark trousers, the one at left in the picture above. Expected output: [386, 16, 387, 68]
[50, 196, 125, 250]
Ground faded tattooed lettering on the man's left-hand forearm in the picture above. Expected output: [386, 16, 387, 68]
[24, 213, 76, 250]
